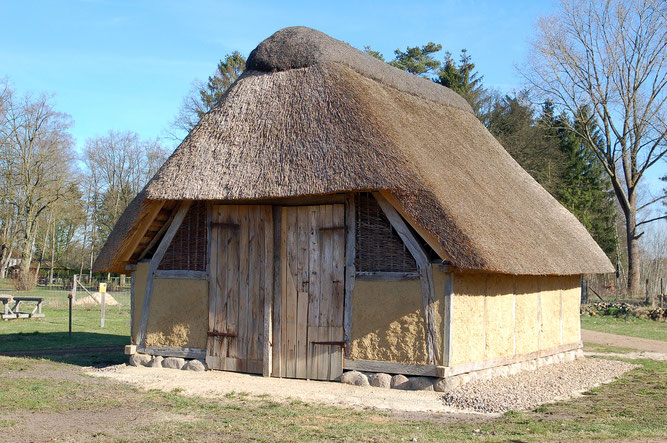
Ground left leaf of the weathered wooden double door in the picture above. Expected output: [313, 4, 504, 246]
[206, 205, 273, 374]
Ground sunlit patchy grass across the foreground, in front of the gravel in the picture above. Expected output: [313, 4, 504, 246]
[0, 357, 667, 442]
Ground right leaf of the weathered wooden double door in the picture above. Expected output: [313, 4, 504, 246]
[274, 204, 345, 380]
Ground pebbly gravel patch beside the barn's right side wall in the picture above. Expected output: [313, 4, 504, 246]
[443, 358, 638, 413]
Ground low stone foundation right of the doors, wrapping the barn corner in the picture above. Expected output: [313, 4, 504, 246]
[340, 349, 584, 392]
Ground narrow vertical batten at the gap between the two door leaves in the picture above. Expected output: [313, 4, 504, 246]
[262, 206, 273, 377]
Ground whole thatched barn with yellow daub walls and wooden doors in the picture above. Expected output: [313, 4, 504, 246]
[95, 27, 613, 386]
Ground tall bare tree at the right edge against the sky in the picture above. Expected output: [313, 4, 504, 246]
[522, 0, 667, 295]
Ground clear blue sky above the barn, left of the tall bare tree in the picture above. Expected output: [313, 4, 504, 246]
[0, 0, 665, 193]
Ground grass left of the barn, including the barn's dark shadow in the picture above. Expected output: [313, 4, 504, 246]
[0, 282, 130, 352]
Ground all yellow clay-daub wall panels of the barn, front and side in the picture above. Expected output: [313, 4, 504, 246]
[132, 262, 580, 366]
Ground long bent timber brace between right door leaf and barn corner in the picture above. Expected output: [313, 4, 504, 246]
[373, 192, 438, 365]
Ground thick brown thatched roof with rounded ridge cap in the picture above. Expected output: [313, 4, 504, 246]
[96, 27, 613, 275]
